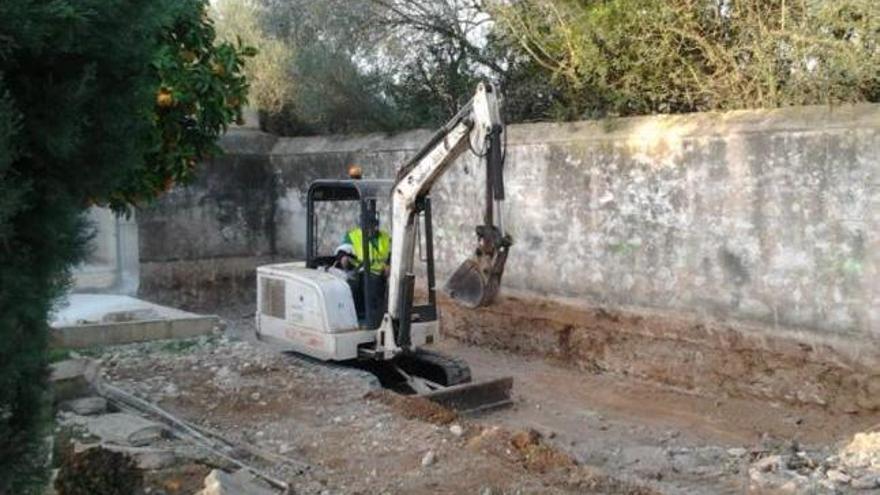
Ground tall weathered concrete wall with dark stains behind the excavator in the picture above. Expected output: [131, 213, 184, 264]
[139, 105, 880, 344]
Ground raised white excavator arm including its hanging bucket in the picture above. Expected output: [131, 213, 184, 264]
[376, 83, 511, 359]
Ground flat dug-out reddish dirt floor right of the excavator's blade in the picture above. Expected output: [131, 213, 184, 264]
[438, 341, 880, 494]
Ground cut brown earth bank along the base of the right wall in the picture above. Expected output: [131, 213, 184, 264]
[440, 295, 880, 413]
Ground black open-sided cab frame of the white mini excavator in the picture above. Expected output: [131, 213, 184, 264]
[306, 179, 437, 330]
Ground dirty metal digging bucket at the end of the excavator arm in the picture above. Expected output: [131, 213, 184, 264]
[444, 225, 512, 308]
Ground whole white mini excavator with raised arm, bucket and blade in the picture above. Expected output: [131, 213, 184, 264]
[256, 83, 513, 411]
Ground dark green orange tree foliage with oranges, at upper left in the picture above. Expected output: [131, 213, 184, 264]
[110, 0, 256, 209]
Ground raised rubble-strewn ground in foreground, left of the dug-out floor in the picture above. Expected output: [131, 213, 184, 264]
[97, 328, 653, 494]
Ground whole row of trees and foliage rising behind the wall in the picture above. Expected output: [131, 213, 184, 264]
[213, 0, 880, 134]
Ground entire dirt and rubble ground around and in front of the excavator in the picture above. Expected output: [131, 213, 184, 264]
[81, 292, 880, 495]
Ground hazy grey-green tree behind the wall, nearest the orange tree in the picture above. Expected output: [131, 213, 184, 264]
[234, 0, 401, 135]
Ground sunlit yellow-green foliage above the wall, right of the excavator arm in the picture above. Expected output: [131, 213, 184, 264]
[495, 0, 880, 119]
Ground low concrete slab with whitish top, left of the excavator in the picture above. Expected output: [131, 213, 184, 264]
[51, 294, 220, 348]
